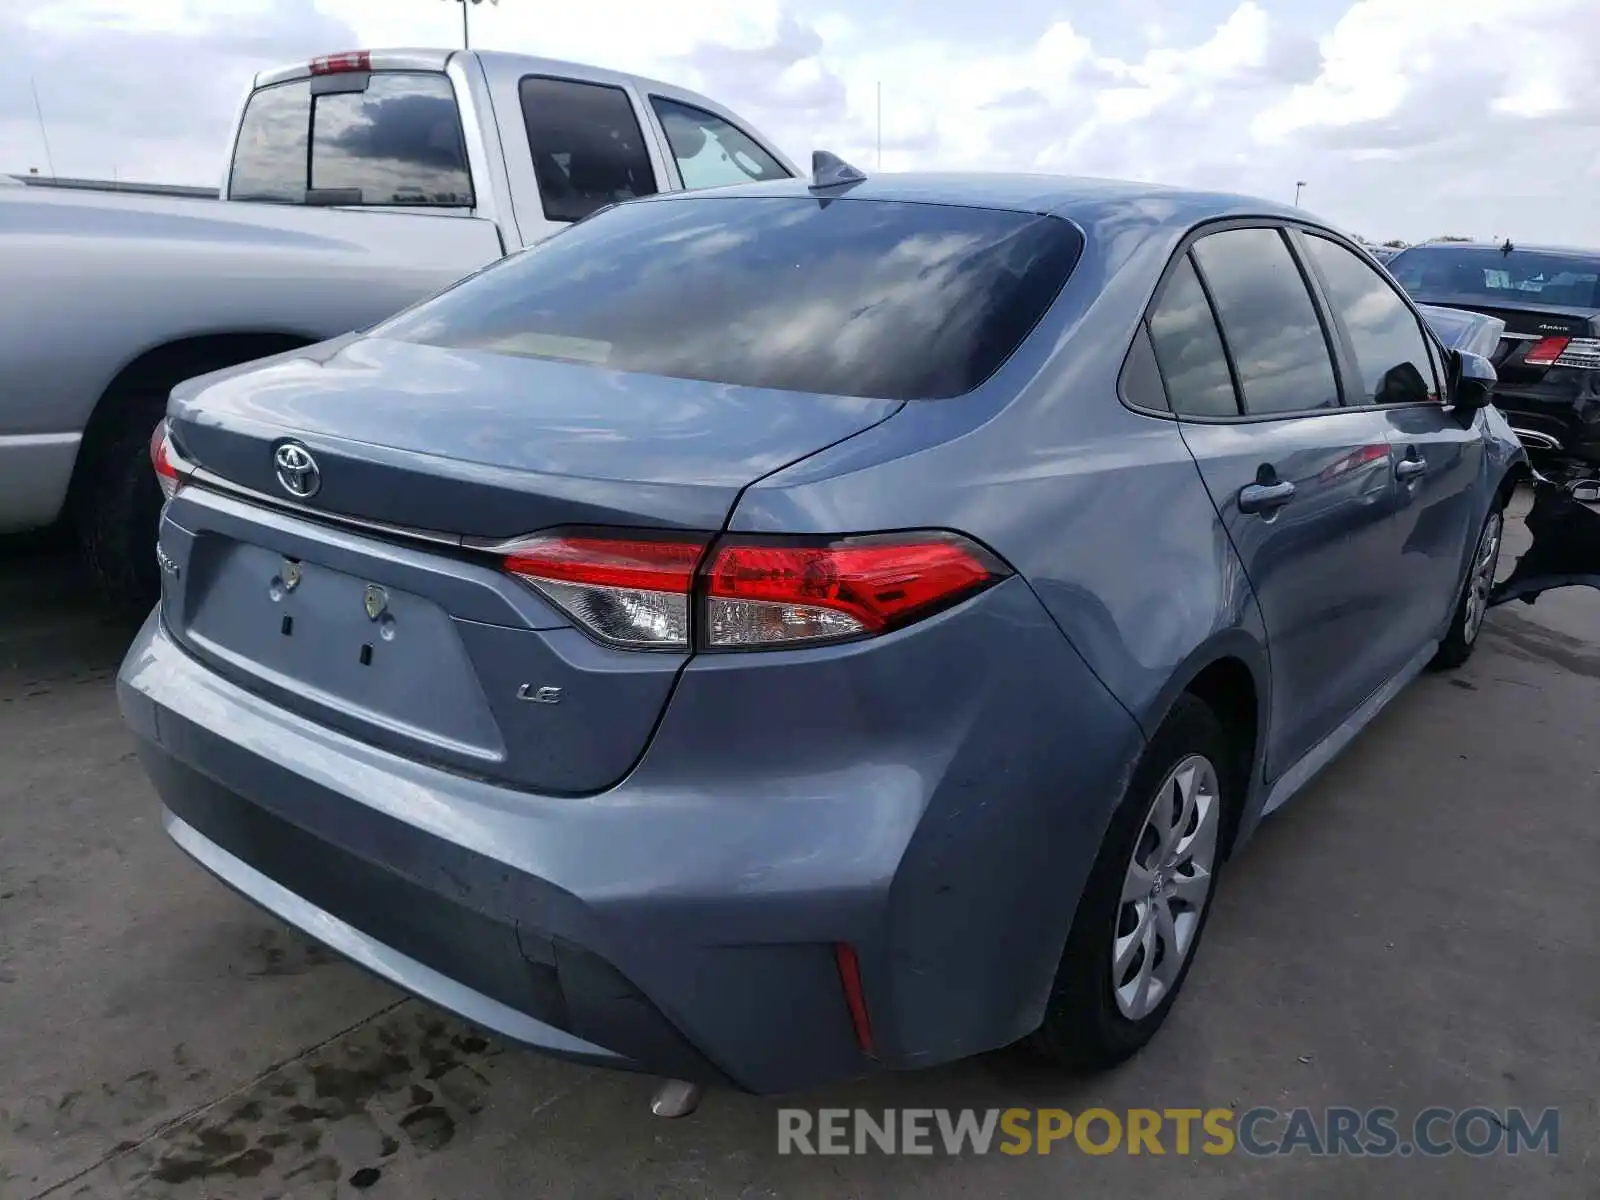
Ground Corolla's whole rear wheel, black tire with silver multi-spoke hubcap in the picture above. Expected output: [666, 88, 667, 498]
[1032, 696, 1235, 1070]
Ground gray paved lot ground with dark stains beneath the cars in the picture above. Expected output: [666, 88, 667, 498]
[0, 492, 1600, 1200]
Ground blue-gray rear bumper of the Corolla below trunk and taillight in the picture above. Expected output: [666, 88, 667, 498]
[118, 581, 1139, 1093]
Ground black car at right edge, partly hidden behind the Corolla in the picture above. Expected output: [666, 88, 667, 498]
[1386, 242, 1600, 475]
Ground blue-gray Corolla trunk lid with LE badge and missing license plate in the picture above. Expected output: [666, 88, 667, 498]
[160, 339, 899, 794]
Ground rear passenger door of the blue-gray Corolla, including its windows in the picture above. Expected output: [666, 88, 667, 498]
[1149, 226, 1395, 778]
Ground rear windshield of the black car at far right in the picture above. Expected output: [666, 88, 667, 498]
[1389, 246, 1600, 309]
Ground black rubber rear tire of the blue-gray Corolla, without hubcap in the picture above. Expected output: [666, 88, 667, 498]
[1030, 696, 1240, 1072]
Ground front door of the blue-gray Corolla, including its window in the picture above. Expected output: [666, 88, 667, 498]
[1296, 232, 1488, 668]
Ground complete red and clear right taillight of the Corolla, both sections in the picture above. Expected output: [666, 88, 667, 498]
[502, 533, 1008, 650]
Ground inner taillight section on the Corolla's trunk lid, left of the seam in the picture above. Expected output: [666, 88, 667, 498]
[504, 534, 706, 650]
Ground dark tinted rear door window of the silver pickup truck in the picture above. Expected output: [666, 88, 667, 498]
[522, 75, 656, 221]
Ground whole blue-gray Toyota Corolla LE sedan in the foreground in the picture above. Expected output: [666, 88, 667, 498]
[120, 162, 1525, 1091]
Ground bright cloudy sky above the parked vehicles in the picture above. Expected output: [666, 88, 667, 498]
[0, 0, 1600, 245]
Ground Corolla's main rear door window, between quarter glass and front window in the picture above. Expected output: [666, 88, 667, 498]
[1194, 229, 1339, 414]
